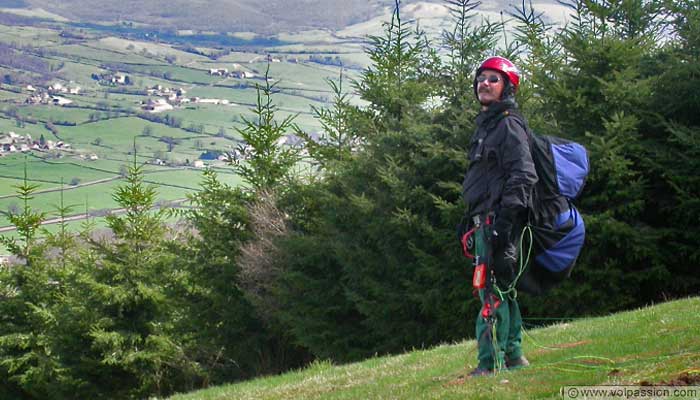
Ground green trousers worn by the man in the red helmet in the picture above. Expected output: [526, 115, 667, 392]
[475, 226, 523, 370]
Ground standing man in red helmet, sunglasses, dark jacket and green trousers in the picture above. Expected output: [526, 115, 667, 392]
[460, 57, 537, 376]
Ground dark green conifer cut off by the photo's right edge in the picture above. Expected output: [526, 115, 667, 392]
[646, 1, 700, 296]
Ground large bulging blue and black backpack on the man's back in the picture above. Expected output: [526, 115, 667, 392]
[510, 113, 589, 293]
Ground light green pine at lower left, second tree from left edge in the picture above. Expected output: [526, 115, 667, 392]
[60, 159, 201, 398]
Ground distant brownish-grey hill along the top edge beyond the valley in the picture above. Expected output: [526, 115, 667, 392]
[8, 0, 412, 33]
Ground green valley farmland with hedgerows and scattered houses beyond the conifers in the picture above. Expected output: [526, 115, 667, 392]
[0, 3, 378, 253]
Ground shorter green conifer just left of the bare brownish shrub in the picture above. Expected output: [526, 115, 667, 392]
[172, 169, 264, 384]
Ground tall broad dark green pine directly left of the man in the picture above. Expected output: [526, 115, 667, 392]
[277, 3, 476, 360]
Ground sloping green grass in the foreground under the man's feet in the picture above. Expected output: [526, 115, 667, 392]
[171, 298, 700, 400]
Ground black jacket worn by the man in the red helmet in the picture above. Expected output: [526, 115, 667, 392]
[462, 101, 537, 219]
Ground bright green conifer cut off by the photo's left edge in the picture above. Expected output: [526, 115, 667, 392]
[0, 168, 75, 399]
